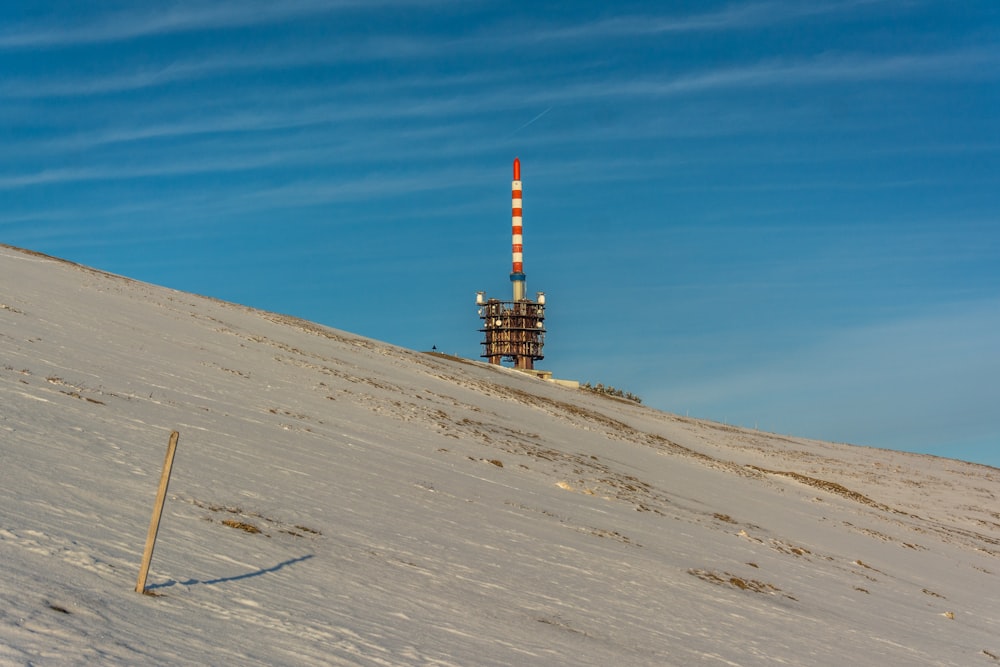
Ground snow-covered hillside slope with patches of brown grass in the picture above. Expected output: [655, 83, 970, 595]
[0, 241, 1000, 665]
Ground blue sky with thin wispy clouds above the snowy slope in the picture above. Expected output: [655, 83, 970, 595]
[0, 0, 1000, 467]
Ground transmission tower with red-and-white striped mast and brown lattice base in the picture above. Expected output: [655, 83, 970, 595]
[476, 158, 545, 370]
